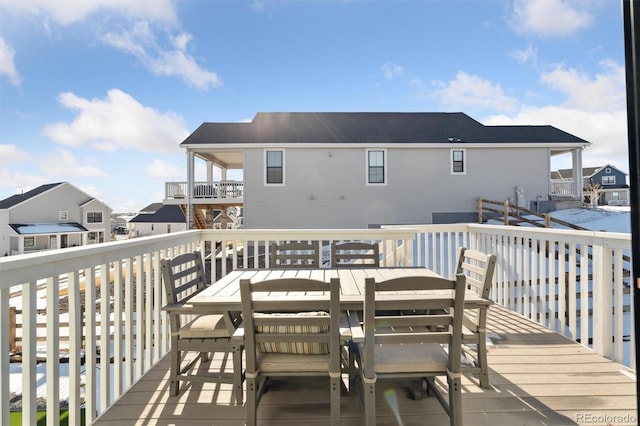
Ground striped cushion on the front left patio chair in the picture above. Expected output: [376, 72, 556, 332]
[256, 311, 329, 355]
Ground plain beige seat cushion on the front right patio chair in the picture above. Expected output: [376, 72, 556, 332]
[359, 343, 448, 373]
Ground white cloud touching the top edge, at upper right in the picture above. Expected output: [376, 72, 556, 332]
[511, 0, 593, 37]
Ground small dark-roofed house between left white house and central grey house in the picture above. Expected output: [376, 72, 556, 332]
[128, 203, 187, 237]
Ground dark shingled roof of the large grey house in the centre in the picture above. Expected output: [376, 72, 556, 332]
[182, 112, 589, 145]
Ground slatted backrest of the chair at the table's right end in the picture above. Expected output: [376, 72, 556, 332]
[456, 247, 496, 299]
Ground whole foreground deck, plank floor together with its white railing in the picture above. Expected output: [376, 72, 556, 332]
[0, 224, 637, 425]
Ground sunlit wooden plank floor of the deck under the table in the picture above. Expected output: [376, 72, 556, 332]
[94, 306, 638, 426]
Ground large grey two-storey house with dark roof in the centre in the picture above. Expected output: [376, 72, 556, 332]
[164, 112, 590, 228]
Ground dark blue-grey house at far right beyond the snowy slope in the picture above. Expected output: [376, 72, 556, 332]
[551, 164, 630, 206]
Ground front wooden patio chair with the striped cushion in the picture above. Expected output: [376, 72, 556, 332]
[240, 278, 342, 426]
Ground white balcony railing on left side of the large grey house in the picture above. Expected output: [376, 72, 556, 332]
[164, 180, 244, 206]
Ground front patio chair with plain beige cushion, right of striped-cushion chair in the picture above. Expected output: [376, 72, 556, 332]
[358, 274, 465, 426]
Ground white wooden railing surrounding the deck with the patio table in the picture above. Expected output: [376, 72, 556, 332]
[0, 224, 635, 425]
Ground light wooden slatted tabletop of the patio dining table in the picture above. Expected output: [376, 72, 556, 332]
[189, 268, 492, 311]
